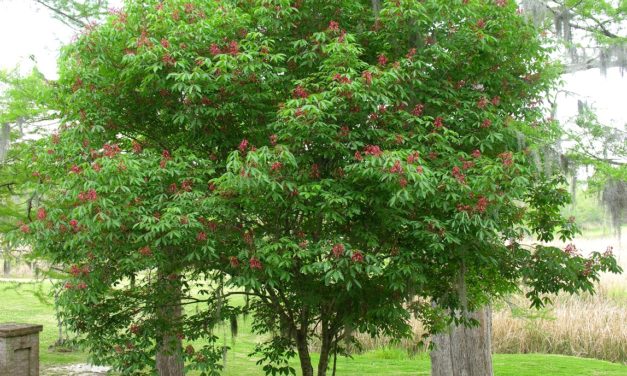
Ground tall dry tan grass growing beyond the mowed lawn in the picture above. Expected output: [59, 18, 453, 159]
[357, 281, 627, 364]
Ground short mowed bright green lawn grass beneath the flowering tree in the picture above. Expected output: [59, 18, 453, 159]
[0, 282, 627, 376]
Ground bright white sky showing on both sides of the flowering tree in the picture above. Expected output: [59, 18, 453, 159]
[0, 0, 627, 129]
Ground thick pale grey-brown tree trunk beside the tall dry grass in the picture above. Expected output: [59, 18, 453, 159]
[431, 306, 493, 376]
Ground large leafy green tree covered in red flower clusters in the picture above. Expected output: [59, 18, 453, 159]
[12, 0, 618, 375]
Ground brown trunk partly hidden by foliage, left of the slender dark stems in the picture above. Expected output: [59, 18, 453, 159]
[156, 274, 185, 376]
